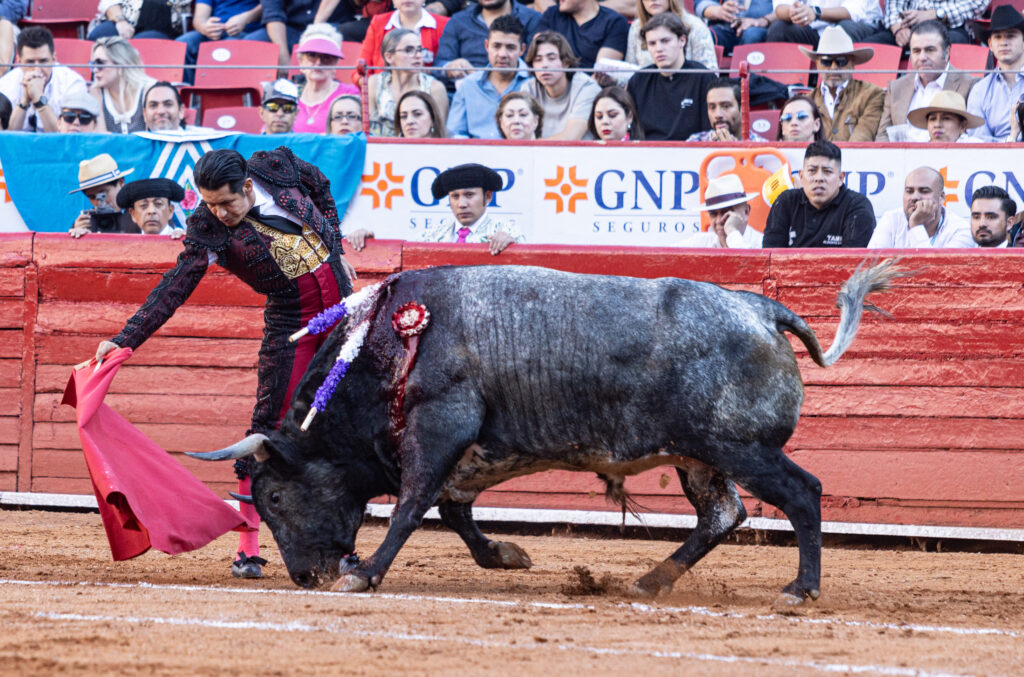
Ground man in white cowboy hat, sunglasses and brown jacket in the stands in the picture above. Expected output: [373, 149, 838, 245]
[800, 26, 885, 141]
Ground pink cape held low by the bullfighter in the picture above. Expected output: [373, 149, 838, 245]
[62, 348, 251, 561]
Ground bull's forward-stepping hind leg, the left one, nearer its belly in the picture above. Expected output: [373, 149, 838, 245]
[633, 461, 746, 597]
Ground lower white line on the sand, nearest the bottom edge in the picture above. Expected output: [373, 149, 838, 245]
[29, 611, 967, 677]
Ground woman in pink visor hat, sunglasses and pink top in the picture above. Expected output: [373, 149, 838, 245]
[292, 24, 359, 134]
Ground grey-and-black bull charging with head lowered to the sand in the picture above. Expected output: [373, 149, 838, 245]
[196, 261, 901, 603]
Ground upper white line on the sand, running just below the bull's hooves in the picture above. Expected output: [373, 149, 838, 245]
[0, 579, 1024, 638]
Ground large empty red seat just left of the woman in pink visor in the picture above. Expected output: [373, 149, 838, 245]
[181, 40, 278, 116]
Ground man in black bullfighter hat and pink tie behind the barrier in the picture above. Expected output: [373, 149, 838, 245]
[346, 163, 524, 255]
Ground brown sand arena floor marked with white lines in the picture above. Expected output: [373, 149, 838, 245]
[0, 510, 1024, 677]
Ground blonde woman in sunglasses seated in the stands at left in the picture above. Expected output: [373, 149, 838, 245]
[89, 36, 156, 134]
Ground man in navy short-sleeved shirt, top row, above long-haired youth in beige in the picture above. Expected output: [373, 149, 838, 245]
[530, 0, 630, 69]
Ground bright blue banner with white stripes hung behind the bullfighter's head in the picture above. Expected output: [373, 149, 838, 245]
[0, 129, 367, 232]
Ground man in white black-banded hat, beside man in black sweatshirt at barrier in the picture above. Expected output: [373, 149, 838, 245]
[676, 174, 761, 249]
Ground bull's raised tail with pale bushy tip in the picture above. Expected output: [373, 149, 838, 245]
[776, 258, 913, 367]
